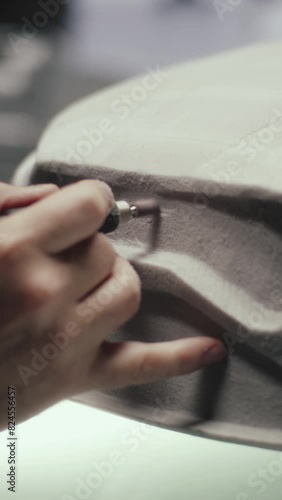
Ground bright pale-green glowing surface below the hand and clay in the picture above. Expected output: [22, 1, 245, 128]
[0, 401, 282, 500]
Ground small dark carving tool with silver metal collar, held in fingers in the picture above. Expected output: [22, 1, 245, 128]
[100, 199, 160, 234]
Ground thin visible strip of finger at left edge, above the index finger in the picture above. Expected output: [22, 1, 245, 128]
[0, 183, 59, 212]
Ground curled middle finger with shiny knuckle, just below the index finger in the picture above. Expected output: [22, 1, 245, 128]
[0, 233, 117, 332]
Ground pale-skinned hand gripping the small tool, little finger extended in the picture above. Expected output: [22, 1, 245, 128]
[0, 180, 226, 429]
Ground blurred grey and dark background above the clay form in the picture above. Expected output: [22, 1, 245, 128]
[0, 0, 282, 184]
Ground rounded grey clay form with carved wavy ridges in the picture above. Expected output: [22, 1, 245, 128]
[14, 44, 282, 449]
